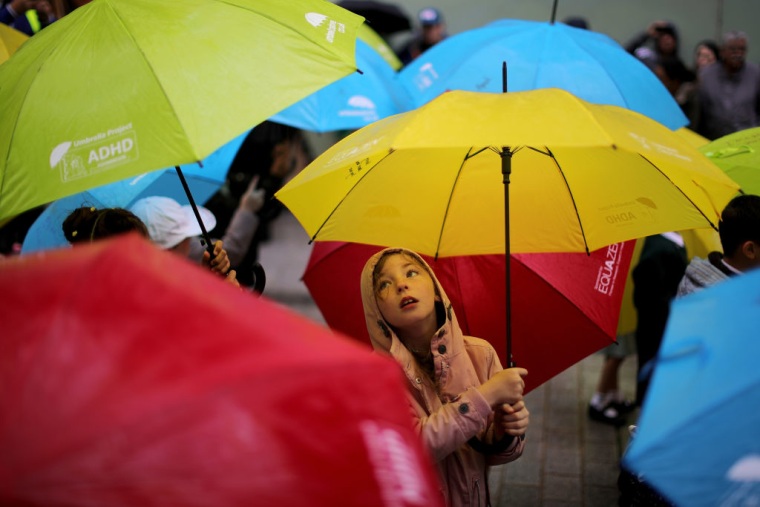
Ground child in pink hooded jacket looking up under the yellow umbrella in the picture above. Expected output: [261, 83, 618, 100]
[361, 248, 529, 506]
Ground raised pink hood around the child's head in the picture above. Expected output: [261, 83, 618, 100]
[361, 248, 462, 355]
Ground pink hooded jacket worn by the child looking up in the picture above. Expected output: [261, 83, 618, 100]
[361, 248, 524, 507]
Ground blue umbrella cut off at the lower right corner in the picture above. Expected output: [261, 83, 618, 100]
[623, 269, 760, 507]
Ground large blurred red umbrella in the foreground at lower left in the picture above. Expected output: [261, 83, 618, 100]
[0, 236, 439, 507]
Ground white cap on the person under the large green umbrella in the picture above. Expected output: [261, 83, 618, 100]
[129, 196, 216, 250]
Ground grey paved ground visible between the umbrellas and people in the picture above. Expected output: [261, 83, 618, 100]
[259, 210, 636, 507]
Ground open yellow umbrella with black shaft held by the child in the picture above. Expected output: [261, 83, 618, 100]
[276, 89, 738, 366]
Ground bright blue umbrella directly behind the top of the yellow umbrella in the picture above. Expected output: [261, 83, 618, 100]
[399, 19, 689, 130]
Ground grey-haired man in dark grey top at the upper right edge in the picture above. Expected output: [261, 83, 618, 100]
[694, 31, 760, 140]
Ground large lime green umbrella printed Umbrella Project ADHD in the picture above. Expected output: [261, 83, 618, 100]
[0, 0, 362, 220]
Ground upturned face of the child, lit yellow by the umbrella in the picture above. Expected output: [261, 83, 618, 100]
[374, 254, 437, 332]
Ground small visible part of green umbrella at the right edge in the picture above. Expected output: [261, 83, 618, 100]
[699, 127, 760, 195]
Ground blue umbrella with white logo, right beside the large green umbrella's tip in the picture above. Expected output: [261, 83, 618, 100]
[270, 39, 413, 132]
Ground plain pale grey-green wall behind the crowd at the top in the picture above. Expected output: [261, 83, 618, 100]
[383, 0, 760, 65]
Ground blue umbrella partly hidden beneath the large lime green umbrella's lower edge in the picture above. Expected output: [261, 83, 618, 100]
[21, 132, 248, 254]
